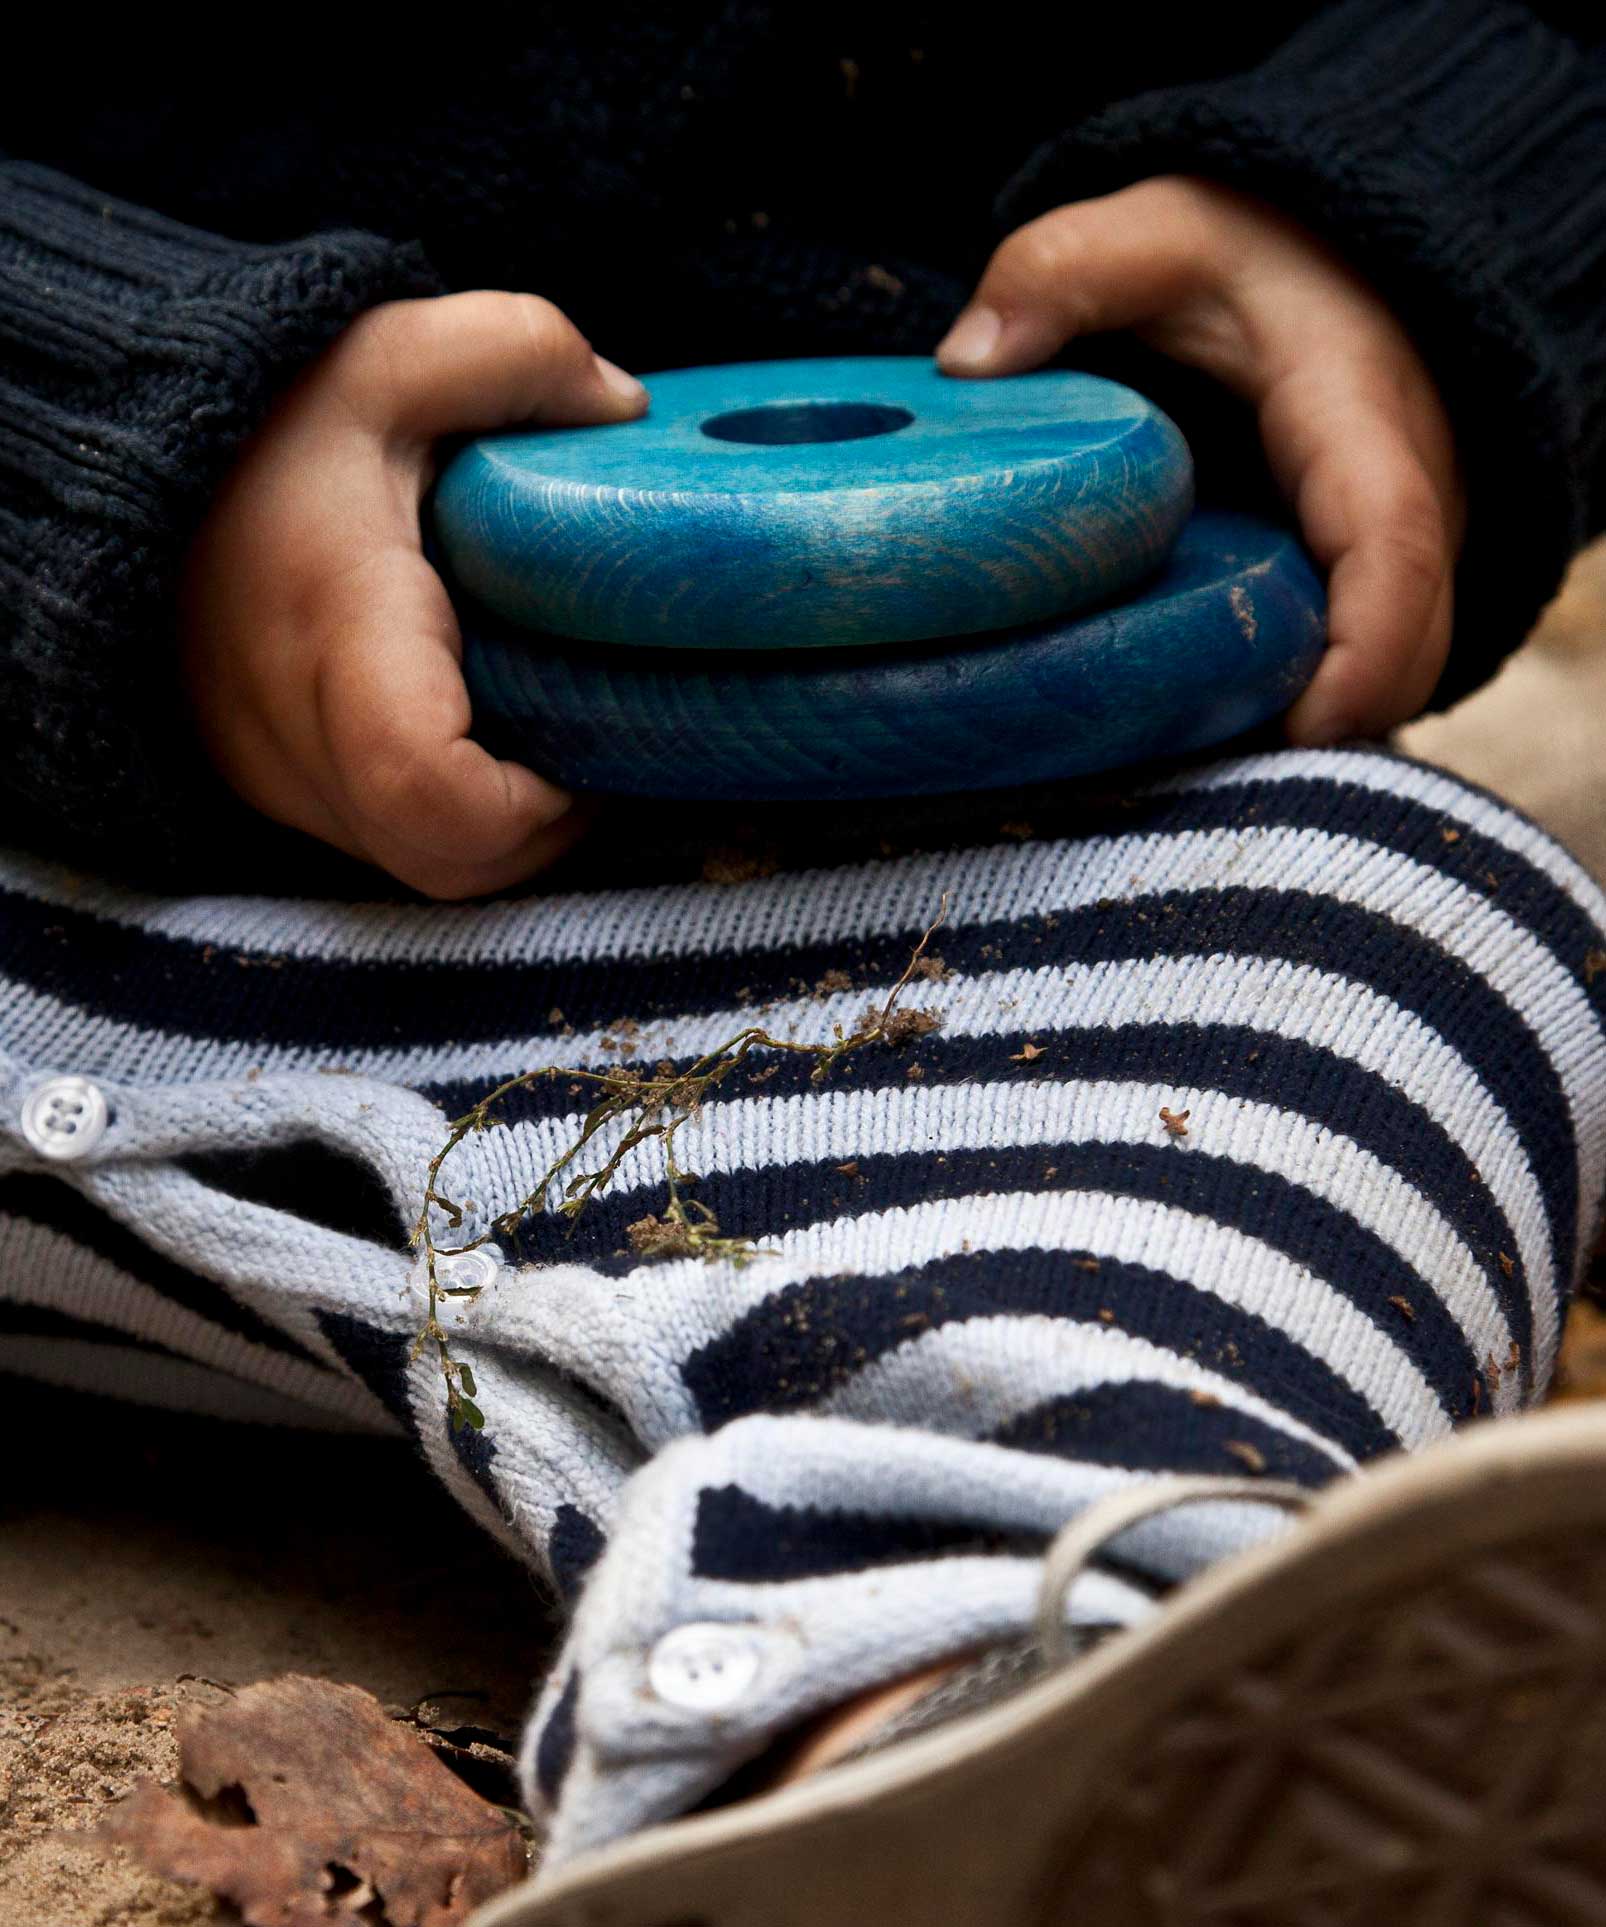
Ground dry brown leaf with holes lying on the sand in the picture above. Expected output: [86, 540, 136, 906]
[100, 1675, 524, 1927]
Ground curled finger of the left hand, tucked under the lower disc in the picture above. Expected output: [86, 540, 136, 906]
[316, 549, 571, 875]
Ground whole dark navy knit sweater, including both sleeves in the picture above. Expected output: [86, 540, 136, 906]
[0, 0, 1606, 881]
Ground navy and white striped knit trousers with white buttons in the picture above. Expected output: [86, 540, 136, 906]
[0, 752, 1606, 1861]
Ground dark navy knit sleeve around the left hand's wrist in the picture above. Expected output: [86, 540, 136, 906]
[0, 156, 438, 873]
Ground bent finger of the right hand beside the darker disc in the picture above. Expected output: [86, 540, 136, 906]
[1263, 366, 1454, 744]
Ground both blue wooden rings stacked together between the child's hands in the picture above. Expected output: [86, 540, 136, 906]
[434, 358, 1325, 800]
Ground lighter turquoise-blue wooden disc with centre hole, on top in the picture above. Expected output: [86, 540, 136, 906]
[434, 356, 1193, 649]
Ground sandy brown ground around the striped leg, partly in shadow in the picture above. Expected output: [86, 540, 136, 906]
[0, 545, 1606, 1927]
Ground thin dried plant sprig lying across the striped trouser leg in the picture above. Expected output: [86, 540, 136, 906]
[413, 890, 949, 1432]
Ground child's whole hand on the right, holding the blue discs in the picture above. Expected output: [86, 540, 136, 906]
[937, 177, 1465, 744]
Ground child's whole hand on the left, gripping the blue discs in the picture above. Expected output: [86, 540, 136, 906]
[181, 293, 646, 896]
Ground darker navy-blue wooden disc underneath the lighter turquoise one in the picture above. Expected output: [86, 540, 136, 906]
[461, 513, 1326, 802]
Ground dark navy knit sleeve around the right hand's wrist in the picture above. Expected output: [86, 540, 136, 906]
[999, 0, 1606, 703]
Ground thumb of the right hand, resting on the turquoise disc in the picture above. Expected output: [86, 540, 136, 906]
[937, 181, 1218, 376]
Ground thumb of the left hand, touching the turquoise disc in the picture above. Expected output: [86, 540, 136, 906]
[337, 291, 648, 441]
